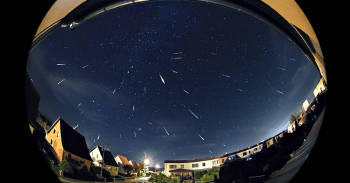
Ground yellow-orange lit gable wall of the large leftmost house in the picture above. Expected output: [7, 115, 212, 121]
[45, 121, 63, 162]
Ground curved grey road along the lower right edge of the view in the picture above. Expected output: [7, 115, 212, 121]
[266, 109, 325, 183]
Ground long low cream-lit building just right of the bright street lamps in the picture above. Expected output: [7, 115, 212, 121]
[164, 157, 220, 176]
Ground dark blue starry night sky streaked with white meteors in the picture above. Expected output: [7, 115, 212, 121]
[27, 2, 320, 165]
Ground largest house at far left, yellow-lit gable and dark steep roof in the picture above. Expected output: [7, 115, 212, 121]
[45, 117, 92, 170]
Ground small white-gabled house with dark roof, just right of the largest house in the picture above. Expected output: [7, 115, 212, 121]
[90, 146, 119, 176]
